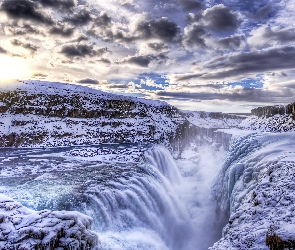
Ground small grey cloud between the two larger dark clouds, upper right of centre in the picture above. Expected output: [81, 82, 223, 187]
[183, 24, 207, 48]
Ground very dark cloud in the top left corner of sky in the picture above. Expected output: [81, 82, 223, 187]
[0, 0, 53, 24]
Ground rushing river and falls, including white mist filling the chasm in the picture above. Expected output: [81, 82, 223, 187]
[0, 144, 224, 250]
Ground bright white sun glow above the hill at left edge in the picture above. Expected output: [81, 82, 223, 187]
[0, 56, 31, 84]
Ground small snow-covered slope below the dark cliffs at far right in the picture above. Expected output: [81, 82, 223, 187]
[238, 114, 295, 132]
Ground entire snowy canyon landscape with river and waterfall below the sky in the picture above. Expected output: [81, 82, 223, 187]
[0, 81, 295, 250]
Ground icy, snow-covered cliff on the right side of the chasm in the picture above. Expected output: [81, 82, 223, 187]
[210, 132, 295, 250]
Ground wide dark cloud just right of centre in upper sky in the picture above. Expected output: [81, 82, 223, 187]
[136, 17, 180, 42]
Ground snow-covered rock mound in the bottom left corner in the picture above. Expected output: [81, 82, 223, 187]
[0, 194, 100, 250]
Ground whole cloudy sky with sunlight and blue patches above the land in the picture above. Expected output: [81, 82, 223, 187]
[0, 0, 295, 112]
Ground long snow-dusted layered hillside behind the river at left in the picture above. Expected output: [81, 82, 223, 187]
[0, 82, 192, 147]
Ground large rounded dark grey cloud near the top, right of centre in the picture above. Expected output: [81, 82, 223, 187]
[203, 4, 240, 31]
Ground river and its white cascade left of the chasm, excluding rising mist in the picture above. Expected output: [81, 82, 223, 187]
[0, 145, 194, 250]
